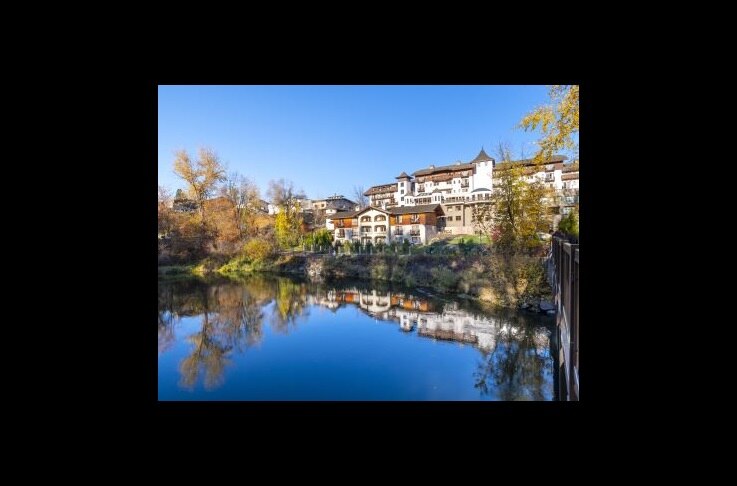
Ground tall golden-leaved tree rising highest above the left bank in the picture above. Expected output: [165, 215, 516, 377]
[174, 148, 225, 226]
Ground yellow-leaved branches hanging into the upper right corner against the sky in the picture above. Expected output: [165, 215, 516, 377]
[519, 84, 578, 164]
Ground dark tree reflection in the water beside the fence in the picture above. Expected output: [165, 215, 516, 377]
[474, 316, 552, 400]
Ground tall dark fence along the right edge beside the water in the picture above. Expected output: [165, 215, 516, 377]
[548, 237, 579, 401]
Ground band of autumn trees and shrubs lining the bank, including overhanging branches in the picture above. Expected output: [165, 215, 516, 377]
[158, 85, 579, 312]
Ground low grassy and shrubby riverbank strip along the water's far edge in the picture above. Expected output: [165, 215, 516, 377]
[159, 254, 552, 311]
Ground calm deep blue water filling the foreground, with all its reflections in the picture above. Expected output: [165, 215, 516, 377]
[158, 277, 553, 400]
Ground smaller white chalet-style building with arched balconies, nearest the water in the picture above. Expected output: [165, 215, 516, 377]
[326, 204, 443, 245]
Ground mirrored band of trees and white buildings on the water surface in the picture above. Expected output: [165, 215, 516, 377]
[158, 276, 553, 400]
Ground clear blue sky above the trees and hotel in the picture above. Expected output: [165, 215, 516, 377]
[158, 86, 549, 199]
